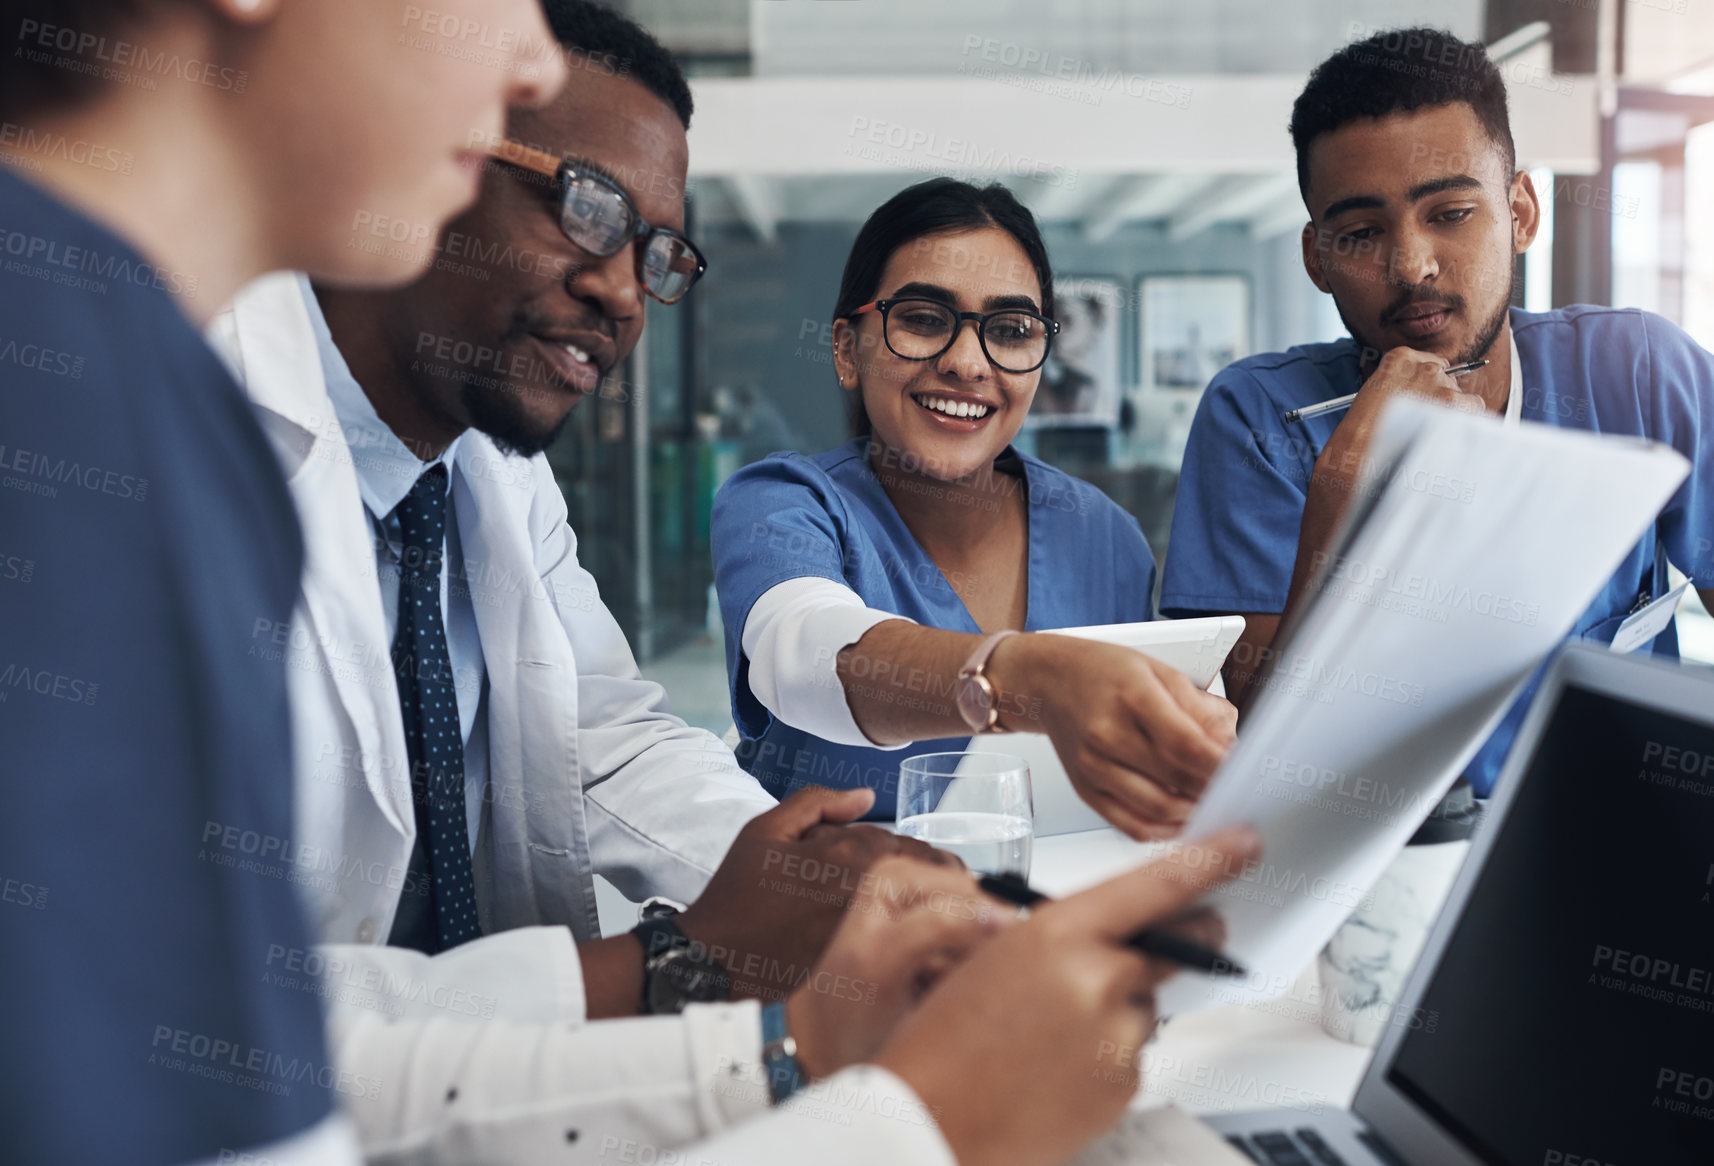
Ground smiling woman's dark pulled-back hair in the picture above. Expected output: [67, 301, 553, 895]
[833, 178, 1054, 437]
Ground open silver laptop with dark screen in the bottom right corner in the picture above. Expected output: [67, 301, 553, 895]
[1205, 645, 1714, 1166]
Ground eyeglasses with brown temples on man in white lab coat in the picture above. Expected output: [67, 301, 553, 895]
[488, 141, 708, 304]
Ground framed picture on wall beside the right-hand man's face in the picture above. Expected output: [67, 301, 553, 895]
[1136, 274, 1250, 396]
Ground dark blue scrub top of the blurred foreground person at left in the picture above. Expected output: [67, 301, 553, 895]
[0, 166, 335, 1166]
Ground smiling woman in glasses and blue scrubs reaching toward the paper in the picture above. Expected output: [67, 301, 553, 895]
[713, 178, 1234, 837]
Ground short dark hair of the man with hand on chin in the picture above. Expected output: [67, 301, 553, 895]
[1291, 27, 1517, 199]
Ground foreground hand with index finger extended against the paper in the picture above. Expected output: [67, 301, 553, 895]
[872, 830, 1262, 1166]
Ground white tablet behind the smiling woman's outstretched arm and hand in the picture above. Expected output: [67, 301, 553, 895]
[970, 616, 1244, 838]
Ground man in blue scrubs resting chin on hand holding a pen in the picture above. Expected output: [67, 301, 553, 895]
[1160, 29, 1714, 796]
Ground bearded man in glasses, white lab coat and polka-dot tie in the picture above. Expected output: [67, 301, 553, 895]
[204, 0, 944, 1157]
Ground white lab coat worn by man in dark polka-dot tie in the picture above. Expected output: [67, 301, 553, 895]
[211, 276, 773, 943]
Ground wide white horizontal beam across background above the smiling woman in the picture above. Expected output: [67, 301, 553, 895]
[691, 74, 1601, 177]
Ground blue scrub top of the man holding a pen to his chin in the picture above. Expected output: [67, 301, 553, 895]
[1160, 307, 1714, 797]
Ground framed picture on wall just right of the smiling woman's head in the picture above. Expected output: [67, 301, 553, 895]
[1028, 276, 1126, 429]
